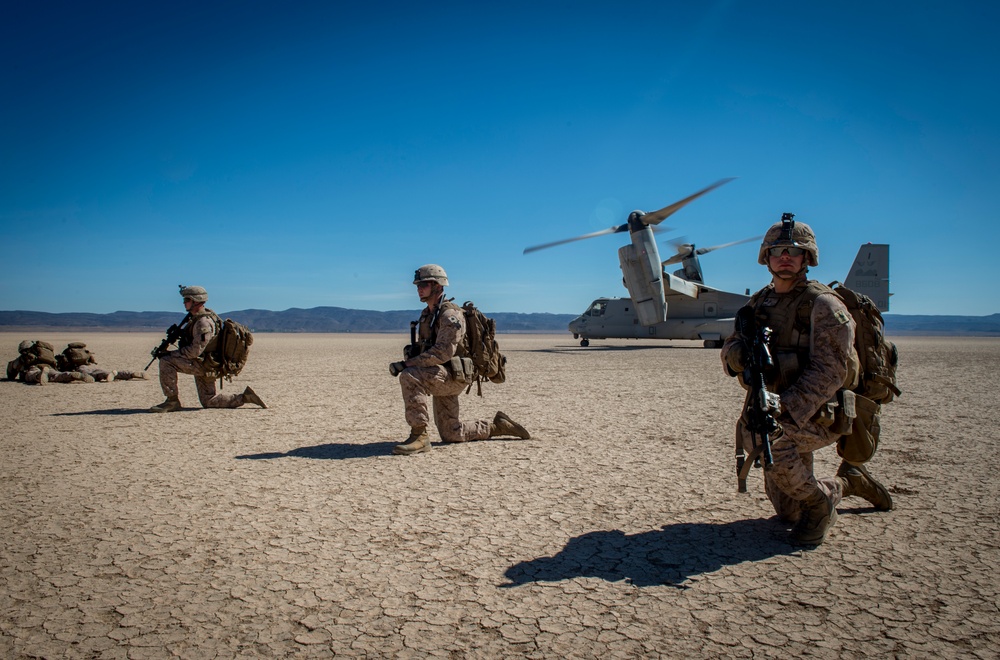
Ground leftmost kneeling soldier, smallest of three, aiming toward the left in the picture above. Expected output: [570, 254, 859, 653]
[150, 285, 267, 413]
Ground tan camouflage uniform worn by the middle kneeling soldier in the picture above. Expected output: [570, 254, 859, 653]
[399, 302, 490, 442]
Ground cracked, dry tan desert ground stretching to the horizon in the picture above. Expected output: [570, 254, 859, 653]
[0, 331, 1000, 658]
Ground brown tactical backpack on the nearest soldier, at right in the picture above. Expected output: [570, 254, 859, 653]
[830, 282, 902, 464]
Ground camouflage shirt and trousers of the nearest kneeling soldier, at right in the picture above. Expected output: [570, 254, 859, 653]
[722, 282, 858, 523]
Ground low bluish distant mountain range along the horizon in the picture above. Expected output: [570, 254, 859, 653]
[0, 307, 1000, 337]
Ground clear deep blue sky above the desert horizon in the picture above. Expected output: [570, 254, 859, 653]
[0, 0, 1000, 315]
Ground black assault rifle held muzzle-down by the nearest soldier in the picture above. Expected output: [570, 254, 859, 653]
[736, 307, 781, 493]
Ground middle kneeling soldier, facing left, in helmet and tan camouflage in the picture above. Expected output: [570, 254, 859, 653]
[389, 264, 531, 455]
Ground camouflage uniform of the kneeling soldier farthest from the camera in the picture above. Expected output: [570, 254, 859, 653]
[160, 308, 244, 408]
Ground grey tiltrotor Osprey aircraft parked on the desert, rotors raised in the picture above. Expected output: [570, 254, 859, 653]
[524, 179, 891, 348]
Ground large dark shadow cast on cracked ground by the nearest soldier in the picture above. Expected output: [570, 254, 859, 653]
[500, 518, 800, 588]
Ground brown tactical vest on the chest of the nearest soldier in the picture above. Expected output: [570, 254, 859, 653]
[747, 280, 858, 392]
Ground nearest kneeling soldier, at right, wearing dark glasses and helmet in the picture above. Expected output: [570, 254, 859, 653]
[721, 213, 893, 545]
